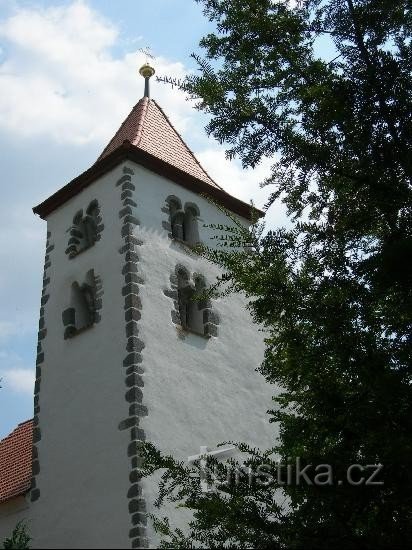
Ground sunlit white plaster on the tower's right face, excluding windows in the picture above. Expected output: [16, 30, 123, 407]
[128, 165, 275, 545]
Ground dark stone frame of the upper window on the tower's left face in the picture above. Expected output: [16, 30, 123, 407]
[65, 199, 104, 260]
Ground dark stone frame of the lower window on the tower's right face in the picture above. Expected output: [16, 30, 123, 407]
[163, 264, 220, 338]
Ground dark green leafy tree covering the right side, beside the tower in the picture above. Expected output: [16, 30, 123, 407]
[142, 0, 412, 548]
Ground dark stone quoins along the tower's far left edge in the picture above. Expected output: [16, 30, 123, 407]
[30, 231, 54, 502]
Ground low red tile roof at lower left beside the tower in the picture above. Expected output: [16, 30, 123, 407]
[0, 420, 33, 502]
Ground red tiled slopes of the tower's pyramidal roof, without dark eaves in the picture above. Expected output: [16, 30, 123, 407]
[97, 97, 221, 189]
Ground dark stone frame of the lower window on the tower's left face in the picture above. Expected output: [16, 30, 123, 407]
[62, 269, 104, 340]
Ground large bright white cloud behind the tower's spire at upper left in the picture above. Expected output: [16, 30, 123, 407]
[0, 0, 191, 144]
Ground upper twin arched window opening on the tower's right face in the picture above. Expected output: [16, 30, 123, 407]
[166, 195, 199, 246]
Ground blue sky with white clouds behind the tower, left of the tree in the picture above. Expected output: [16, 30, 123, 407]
[0, 0, 287, 438]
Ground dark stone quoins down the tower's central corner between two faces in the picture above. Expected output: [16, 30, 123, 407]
[116, 166, 148, 548]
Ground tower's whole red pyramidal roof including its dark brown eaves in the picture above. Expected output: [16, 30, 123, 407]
[33, 93, 263, 219]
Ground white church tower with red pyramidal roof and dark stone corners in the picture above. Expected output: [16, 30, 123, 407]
[2, 65, 273, 548]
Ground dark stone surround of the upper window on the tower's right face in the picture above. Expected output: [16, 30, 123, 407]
[162, 195, 201, 248]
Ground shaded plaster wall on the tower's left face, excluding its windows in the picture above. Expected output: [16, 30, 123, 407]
[32, 167, 130, 548]
